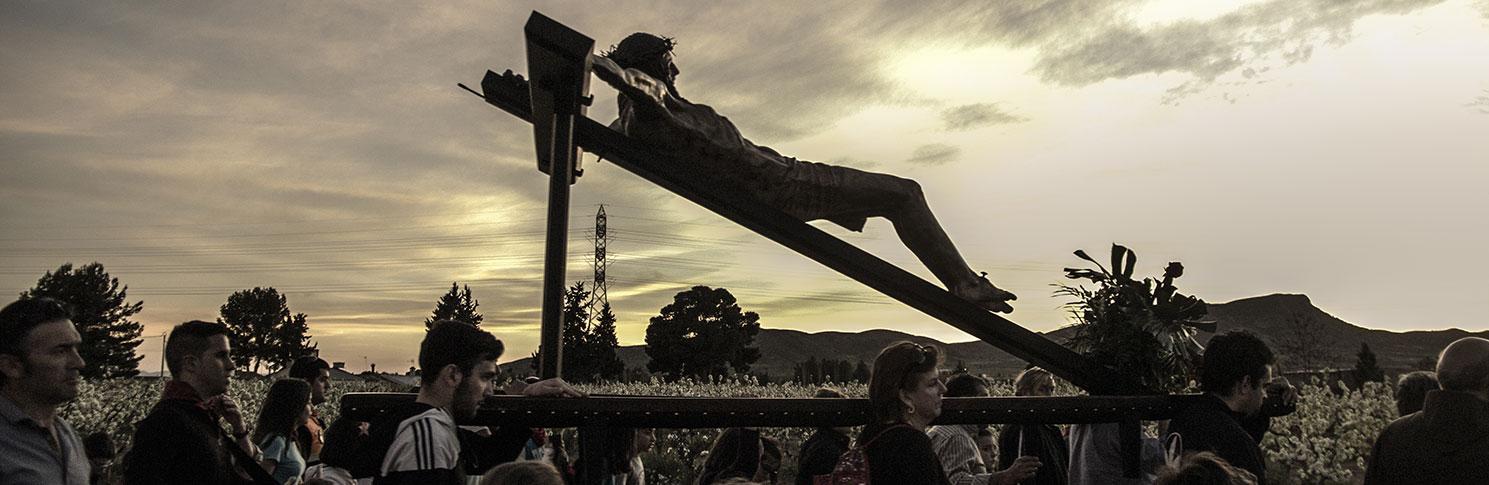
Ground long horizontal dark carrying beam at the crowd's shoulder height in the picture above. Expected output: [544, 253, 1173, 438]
[341, 393, 1202, 428]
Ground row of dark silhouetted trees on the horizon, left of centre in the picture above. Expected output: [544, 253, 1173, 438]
[19, 262, 759, 382]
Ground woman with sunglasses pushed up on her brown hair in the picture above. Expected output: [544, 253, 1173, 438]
[858, 342, 950, 485]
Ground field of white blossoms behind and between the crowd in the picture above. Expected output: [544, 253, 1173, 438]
[63, 379, 1395, 484]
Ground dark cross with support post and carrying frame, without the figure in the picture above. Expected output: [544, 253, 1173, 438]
[341, 12, 1199, 484]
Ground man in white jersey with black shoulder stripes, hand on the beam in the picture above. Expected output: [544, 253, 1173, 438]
[369, 320, 584, 485]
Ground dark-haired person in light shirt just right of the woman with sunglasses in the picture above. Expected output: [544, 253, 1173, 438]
[926, 372, 1042, 485]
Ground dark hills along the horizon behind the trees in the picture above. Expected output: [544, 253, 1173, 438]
[503, 295, 1489, 378]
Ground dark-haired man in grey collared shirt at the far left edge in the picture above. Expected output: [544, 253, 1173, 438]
[0, 298, 89, 485]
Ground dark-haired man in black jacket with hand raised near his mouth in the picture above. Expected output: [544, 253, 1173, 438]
[124, 320, 268, 484]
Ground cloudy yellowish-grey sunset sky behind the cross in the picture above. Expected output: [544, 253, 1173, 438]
[0, 0, 1489, 369]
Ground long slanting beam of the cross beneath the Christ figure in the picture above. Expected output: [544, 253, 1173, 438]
[481, 71, 1151, 394]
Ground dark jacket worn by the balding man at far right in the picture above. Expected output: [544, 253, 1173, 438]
[1365, 391, 1489, 485]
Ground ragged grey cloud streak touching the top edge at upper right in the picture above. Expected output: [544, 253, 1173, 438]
[1033, 0, 1443, 101]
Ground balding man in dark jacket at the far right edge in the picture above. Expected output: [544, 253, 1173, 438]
[1365, 336, 1489, 485]
